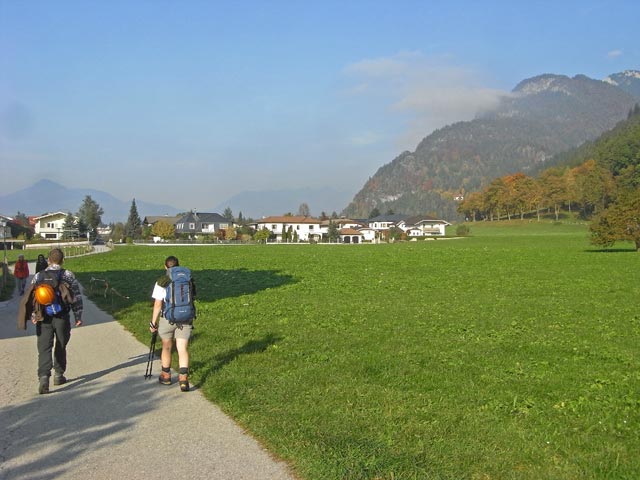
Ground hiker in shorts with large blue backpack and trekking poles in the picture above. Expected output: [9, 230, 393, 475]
[149, 256, 196, 392]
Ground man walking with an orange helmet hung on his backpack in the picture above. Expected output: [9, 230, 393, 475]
[30, 248, 83, 394]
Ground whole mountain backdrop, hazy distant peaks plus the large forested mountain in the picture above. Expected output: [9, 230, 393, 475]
[5, 70, 640, 223]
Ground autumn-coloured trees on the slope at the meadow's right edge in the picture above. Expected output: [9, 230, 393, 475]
[458, 105, 640, 248]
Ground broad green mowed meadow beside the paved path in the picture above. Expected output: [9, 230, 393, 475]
[67, 222, 640, 480]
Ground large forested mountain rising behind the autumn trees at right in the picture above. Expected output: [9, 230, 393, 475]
[344, 70, 640, 220]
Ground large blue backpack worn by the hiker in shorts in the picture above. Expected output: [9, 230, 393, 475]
[162, 267, 196, 323]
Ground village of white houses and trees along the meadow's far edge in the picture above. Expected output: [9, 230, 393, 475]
[0, 211, 450, 249]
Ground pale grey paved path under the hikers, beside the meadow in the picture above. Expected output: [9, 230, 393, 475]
[0, 265, 294, 480]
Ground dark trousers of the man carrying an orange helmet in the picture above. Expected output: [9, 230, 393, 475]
[36, 314, 71, 377]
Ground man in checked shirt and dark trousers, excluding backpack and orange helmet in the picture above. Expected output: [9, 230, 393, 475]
[28, 248, 83, 394]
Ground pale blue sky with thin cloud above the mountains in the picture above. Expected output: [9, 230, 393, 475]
[0, 0, 640, 214]
